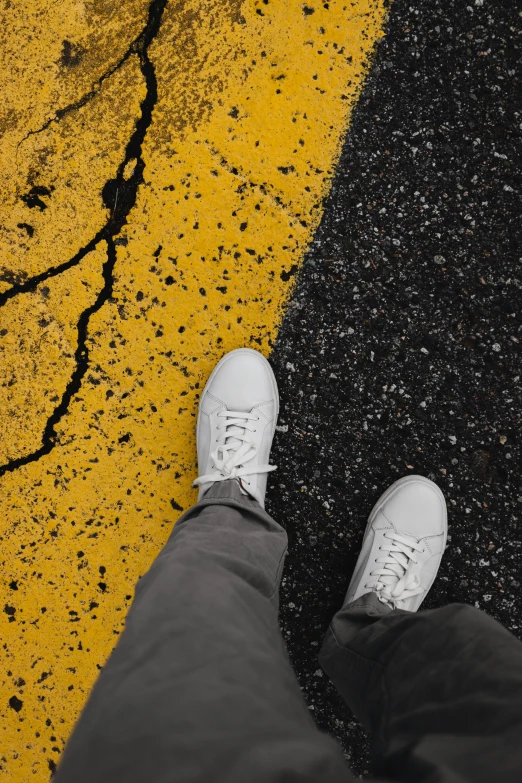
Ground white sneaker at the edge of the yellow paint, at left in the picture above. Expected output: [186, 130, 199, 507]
[193, 348, 279, 508]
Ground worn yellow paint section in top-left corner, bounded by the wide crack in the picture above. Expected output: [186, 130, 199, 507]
[0, 0, 148, 291]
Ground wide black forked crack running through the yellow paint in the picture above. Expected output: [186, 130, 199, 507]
[0, 0, 168, 477]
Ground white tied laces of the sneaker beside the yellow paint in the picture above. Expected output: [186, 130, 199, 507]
[192, 410, 276, 487]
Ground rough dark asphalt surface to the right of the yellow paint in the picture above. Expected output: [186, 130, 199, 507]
[267, 0, 522, 774]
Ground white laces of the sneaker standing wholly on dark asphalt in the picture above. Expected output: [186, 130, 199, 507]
[366, 533, 424, 606]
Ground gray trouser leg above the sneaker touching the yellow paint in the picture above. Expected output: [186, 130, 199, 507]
[56, 481, 350, 783]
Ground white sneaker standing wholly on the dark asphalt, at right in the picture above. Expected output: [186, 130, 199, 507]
[345, 476, 448, 612]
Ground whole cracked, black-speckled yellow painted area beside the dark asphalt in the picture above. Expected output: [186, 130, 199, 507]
[0, 0, 384, 783]
